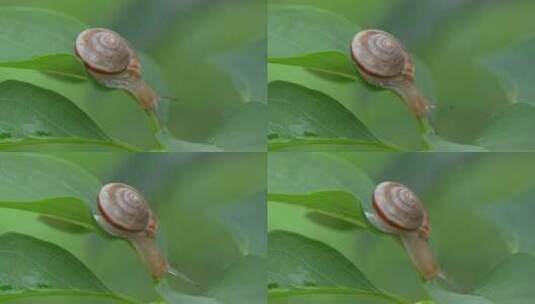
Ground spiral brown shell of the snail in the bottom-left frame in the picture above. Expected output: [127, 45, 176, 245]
[98, 183, 153, 232]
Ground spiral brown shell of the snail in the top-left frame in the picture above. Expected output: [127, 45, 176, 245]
[75, 28, 134, 74]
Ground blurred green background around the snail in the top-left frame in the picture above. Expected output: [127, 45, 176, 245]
[0, 0, 266, 149]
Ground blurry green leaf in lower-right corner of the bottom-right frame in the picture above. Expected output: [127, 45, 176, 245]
[426, 254, 535, 304]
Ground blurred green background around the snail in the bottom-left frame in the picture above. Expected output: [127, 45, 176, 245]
[0, 153, 266, 303]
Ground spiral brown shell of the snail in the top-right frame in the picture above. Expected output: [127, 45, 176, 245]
[351, 30, 410, 78]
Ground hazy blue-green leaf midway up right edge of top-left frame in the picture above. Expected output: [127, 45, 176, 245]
[214, 39, 267, 103]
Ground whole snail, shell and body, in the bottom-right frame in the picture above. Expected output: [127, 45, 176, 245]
[366, 182, 443, 280]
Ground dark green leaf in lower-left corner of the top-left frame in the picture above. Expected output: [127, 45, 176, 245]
[0, 80, 138, 150]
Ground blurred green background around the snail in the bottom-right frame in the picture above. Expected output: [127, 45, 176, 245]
[268, 153, 535, 304]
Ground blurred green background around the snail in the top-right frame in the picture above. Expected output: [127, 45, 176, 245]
[268, 0, 535, 149]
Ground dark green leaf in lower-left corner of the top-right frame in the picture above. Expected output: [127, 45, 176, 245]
[268, 81, 394, 150]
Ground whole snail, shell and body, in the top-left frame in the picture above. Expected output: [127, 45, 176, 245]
[75, 28, 160, 110]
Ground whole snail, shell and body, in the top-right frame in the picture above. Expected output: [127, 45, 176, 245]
[351, 30, 429, 117]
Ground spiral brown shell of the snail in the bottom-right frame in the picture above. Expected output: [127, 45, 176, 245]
[373, 182, 429, 233]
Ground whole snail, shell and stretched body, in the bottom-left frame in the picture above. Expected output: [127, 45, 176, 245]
[95, 183, 197, 285]
